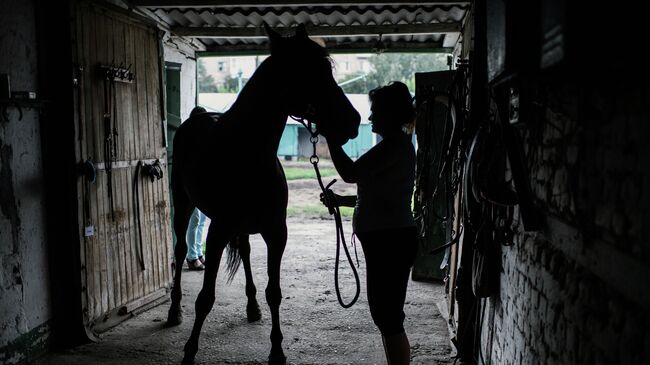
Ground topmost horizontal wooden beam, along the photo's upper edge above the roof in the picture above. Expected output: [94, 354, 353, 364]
[129, 0, 471, 8]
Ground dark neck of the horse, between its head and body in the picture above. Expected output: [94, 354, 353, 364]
[226, 57, 288, 154]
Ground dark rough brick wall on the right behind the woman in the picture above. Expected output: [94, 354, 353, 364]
[480, 74, 650, 364]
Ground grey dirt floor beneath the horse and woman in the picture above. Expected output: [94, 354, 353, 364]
[35, 162, 453, 365]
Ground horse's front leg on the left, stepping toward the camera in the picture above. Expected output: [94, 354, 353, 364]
[182, 224, 230, 365]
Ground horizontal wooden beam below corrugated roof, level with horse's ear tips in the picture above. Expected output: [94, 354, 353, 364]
[171, 23, 461, 38]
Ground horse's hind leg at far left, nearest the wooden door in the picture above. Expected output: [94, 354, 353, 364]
[167, 189, 194, 326]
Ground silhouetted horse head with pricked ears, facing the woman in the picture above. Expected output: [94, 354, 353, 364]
[264, 23, 361, 145]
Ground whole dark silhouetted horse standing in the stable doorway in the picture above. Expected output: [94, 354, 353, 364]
[167, 23, 361, 365]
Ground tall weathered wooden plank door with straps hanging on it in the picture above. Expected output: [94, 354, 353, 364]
[73, 2, 172, 332]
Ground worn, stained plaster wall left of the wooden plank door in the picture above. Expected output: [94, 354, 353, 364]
[0, 0, 52, 364]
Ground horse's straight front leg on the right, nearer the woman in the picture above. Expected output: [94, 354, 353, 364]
[262, 223, 287, 365]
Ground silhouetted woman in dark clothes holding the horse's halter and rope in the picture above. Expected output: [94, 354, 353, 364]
[321, 82, 417, 365]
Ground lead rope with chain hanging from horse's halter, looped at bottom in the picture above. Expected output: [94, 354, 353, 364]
[290, 116, 361, 308]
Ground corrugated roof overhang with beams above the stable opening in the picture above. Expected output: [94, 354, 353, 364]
[133, 0, 470, 52]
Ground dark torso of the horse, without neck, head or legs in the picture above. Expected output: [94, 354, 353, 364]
[172, 112, 287, 231]
